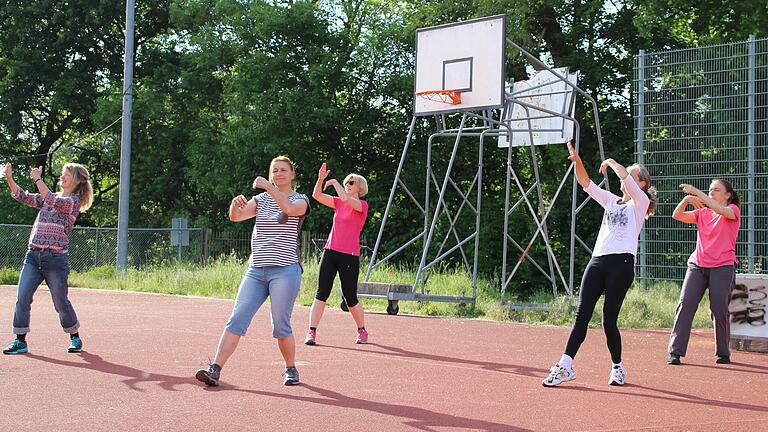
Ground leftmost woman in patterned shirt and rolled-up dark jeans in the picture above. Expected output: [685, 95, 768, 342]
[3, 163, 93, 354]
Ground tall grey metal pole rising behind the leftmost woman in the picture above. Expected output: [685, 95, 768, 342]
[117, 0, 136, 273]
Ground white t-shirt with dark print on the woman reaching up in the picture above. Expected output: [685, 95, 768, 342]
[584, 175, 651, 257]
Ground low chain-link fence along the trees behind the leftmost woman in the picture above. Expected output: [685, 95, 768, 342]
[0, 224, 211, 271]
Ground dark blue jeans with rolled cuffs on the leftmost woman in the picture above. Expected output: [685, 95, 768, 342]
[13, 250, 80, 334]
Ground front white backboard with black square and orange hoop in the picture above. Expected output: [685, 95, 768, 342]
[413, 15, 507, 116]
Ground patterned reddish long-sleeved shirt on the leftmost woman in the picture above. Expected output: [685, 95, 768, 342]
[13, 187, 80, 253]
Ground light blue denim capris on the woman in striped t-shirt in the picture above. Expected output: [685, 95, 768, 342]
[225, 264, 301, 339]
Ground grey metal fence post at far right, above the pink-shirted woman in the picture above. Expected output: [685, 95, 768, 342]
[747, 35, 755, 273]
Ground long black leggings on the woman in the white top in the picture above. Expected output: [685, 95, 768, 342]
[565, 254, 635, 363]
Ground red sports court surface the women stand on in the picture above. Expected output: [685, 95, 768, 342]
[0, 286, 768, 432]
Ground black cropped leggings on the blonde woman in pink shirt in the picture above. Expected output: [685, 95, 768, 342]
[315, 249, 360, 307]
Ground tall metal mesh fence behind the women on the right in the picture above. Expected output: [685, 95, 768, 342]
[633, 37, 768, 282]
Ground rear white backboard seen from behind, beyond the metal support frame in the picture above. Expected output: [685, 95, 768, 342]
[499, 68, 577, 147]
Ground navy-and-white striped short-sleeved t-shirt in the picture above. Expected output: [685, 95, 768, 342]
[248, 192, 309, 267]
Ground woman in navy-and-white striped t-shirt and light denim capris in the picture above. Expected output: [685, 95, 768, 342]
[195, 156, 309, 386]
